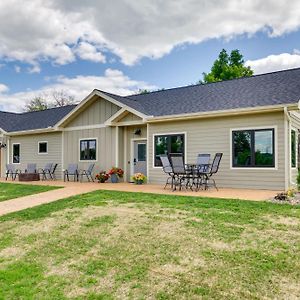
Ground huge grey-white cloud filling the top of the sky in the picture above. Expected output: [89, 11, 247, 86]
[0, 0, 300, 64]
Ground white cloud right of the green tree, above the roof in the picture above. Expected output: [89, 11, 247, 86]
[246, 50, 300, 74]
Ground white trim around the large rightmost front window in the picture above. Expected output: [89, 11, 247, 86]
[229, 125, 278, 172]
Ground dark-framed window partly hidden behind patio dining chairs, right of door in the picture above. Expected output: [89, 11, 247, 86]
[154, 134, 184, 167]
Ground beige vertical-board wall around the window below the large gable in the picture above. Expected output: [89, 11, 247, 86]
[64, 127, 116, 176]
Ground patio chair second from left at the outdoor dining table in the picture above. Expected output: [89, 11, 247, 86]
[169, 153, 193, 191]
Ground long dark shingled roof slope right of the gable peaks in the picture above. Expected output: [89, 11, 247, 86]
[123, 68, 300, 116]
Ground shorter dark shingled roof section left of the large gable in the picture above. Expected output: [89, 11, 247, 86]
[0, 105, 76, 132]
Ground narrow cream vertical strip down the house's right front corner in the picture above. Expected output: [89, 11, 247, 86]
[284, 107, 292, 190]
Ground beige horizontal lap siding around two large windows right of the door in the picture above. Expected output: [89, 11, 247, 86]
[148, 113, 285, 190]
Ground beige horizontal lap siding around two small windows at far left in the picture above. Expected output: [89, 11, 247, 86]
[9, 132, 62, 179]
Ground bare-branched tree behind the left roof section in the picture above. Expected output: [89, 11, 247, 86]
[24, 90, 75, 112]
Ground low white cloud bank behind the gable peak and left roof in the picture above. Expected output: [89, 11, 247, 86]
[0, 69, 157, 111]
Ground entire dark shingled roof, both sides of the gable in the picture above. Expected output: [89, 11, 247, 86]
[0, 68, 300, 132]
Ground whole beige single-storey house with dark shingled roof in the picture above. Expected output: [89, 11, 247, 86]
[0, 68, 300, 190]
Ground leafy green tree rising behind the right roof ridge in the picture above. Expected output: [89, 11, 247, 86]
[200, 49, 253, 83]
